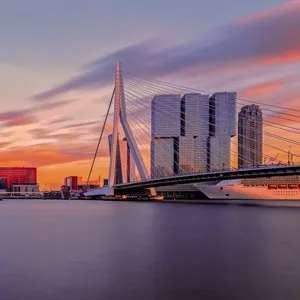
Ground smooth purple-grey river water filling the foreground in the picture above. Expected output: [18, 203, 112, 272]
[0, 200, 300, 300]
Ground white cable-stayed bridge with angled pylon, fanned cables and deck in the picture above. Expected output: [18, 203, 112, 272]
[86, 62, 300, 196]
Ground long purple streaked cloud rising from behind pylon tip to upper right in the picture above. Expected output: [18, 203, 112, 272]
[33, 1, 300, 100]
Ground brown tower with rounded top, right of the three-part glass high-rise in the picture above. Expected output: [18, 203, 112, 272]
[238, 104, 263, 168]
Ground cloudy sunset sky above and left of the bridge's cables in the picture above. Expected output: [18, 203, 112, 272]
[0, 0, 300, 189]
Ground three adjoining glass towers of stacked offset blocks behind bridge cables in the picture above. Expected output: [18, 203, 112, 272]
[150, 92, 236, 178]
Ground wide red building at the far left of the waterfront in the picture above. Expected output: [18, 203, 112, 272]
[0, 167, 37, 191]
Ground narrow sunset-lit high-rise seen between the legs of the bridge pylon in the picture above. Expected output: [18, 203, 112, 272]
[119, 138, 136, 183]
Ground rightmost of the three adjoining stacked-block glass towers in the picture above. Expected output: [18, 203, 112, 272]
[207, 92, 236, 171]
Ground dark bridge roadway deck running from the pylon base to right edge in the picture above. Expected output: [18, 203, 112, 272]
[113, 165, 300, 190]
